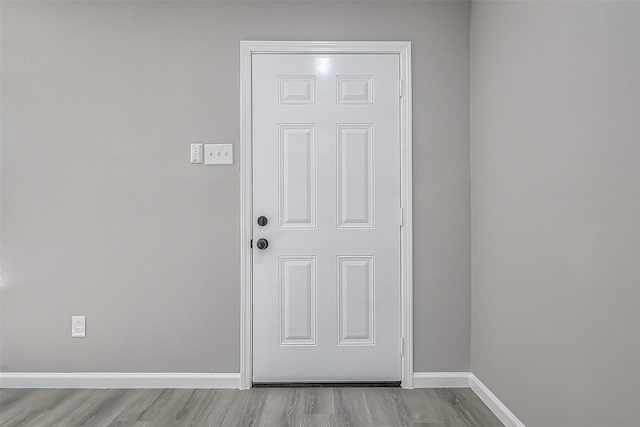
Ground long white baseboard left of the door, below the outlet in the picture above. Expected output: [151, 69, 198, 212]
[0, 372, 240, 388]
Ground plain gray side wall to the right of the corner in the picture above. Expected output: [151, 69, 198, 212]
[471, 2, 640, 427]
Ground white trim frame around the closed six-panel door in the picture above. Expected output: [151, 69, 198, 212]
[240, 41, 413, 389]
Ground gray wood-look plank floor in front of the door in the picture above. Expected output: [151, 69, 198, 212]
[0, 388, 502, 427]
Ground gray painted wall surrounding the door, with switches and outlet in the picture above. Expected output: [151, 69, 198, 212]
[0, 2, 470, 372]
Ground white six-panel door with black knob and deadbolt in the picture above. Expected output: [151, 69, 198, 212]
[252, 54, 401, 382]
